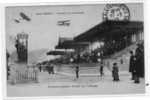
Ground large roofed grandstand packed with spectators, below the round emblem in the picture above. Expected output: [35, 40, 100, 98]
[50, 21, 144, 63]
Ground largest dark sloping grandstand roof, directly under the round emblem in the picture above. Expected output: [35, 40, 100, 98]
[74, 21, 143, 42]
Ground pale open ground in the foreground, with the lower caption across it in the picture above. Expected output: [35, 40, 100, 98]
[7, 65, 145, 97]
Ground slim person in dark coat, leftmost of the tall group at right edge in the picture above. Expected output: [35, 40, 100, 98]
[129, 51, 136, 80]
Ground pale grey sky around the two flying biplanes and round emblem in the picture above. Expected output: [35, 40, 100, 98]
[5, 3, 144, 52]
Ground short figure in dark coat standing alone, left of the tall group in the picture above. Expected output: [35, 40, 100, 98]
[112, 63, 119, 81]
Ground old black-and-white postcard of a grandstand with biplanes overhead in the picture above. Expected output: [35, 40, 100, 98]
[4, 2, 145, 97]
